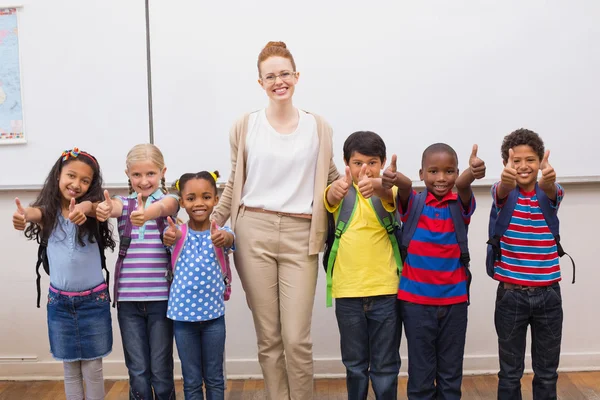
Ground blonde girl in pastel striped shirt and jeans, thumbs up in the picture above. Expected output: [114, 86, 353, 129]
[96, 144, 179, 400]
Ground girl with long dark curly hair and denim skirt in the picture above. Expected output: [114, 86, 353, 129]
[13, 148, 115, 400]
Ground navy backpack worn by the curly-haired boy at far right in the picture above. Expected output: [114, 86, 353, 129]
[485, 183, 575, 283]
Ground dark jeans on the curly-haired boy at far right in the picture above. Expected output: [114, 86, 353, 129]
[494, 283, 563, 400]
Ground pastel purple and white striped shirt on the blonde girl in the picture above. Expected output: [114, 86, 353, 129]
[115, 189, 177, 301]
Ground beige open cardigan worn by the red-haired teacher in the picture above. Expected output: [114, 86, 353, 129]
[212, 114, 340, 254]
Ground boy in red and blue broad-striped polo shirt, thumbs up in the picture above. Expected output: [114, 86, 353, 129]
[382, 143, 485, 399]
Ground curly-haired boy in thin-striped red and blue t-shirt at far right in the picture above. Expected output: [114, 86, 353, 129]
[492, 129, 564, 400]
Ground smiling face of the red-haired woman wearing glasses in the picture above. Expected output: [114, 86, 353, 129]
[258, 56, 299, 102]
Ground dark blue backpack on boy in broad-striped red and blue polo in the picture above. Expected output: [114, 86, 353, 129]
[398, 189, 472, 303]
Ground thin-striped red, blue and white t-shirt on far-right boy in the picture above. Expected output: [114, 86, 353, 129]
[492, 182, 564, 286]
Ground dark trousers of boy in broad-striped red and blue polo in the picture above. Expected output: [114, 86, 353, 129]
[400, 301, 467, 400]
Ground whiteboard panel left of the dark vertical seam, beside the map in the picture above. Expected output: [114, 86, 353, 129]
[0, 0, 149, 188]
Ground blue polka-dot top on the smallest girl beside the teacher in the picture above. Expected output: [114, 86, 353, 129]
[167, 226, 235, 322]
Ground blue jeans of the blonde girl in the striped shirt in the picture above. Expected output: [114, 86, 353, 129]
[118, 300, 175, 400]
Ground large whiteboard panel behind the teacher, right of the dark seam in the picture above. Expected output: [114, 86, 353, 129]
[150, 0, 600, 184]
